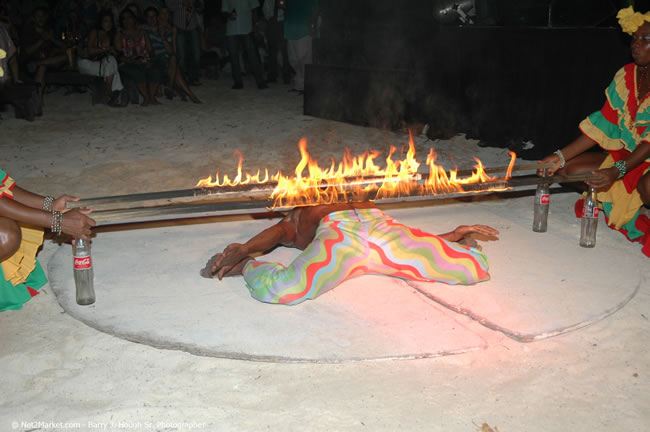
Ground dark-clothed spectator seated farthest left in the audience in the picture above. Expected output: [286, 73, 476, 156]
[20, 7, 68, 114]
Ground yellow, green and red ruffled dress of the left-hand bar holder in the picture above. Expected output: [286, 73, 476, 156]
[0, 169, 47, 312]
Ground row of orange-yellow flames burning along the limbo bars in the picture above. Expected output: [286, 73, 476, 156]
[197, 132, 517, 208]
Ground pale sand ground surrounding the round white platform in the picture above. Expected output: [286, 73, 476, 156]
[0, 78, 650, 432]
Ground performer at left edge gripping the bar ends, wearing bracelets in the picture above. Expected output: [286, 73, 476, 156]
[0, 169, 95, 312]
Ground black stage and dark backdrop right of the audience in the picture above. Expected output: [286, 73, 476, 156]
[305, 0, 631, 159]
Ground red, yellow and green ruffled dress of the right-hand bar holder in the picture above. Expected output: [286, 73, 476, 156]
[576, 63, 650, 256]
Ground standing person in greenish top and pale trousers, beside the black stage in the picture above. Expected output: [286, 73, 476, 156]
[284, 0, 318, 94]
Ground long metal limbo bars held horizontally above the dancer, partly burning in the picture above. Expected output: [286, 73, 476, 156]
[68, 164, 595, 225]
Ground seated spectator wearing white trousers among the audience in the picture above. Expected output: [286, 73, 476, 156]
[77, 11, 124, 107]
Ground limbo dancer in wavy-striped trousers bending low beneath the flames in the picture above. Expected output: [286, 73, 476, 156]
[201, 202, 499, 304]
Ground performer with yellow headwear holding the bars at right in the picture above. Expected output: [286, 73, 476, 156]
[542, 6, 650, 256]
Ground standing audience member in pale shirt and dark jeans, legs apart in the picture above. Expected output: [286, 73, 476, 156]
[221, 0, 267, 89]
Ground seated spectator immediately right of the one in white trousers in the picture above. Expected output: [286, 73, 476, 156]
[114, 8, 164, 106]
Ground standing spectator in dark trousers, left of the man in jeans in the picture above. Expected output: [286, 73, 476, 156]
[167, 0, 203, 85]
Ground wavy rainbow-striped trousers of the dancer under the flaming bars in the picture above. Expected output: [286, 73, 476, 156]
[243, 208, 490, 304]
